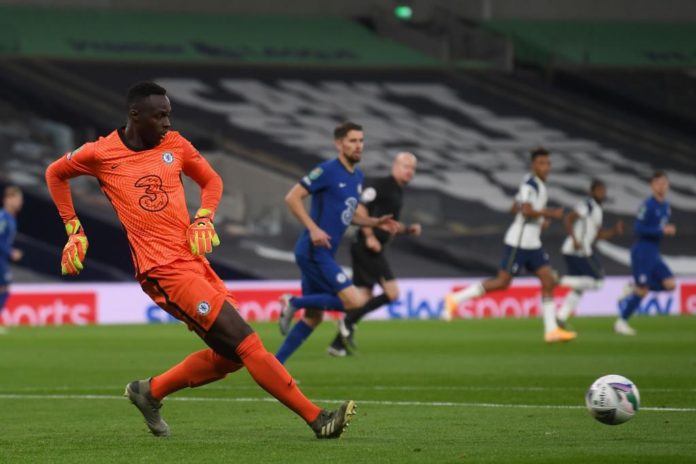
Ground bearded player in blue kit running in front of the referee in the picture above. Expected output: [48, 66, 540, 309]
[276, 122, 400, 363]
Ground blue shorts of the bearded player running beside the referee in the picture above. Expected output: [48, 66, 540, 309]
[295, 247, 353, 295]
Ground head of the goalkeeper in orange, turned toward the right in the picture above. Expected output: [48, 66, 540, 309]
[126, 81, 172, 149]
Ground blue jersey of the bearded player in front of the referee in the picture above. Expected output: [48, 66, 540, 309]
[295, 159, 363, 255]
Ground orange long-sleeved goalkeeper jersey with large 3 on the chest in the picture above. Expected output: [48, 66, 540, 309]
[46, 130, 222, 275]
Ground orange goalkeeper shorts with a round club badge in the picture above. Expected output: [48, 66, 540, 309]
[138, 259, 237, 336]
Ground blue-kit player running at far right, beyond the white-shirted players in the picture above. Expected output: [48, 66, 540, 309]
[614, 171, 677, 335]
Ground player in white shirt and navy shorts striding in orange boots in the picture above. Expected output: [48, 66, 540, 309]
[444, 148, 576, 343]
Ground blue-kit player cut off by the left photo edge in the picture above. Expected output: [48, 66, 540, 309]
[0, 185, 23, 334]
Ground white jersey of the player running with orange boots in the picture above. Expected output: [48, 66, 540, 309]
[505, 174, 548, 250]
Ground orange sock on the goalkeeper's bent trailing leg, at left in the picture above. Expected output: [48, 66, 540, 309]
[150, 348, 242, 400]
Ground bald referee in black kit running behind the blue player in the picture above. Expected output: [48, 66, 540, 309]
[328, 152, 421, 357]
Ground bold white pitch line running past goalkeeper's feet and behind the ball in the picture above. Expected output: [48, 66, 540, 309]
[0, 393, 696, 412]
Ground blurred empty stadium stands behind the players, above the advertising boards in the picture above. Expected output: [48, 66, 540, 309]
[0, 0, 696, 282]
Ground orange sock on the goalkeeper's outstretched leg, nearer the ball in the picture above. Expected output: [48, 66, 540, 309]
[237, 333, 321, 423]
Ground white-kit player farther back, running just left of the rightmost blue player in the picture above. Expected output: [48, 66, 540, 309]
[557, 180, 624, 329]
